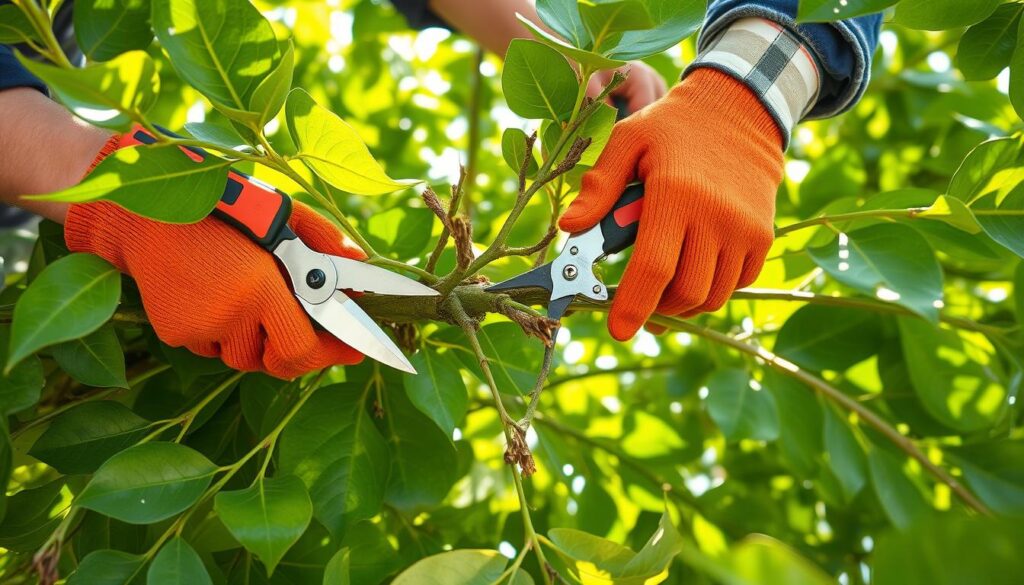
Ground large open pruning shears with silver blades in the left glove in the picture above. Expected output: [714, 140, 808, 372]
[121, 129, 440, 374]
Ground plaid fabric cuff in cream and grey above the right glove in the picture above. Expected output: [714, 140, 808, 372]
[683, 18, 821, 148]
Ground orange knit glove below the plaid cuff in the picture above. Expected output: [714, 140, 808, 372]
[559, 69, 783, 340]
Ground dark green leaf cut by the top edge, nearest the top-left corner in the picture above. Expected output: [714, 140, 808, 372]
[74, 0, 153, 61]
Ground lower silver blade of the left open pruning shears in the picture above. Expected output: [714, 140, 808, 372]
[297, 292, 416, 374]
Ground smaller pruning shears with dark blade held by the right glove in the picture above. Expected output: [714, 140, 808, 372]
[486, 182, 644, 320]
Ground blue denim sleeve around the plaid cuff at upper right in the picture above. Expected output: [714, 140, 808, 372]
[698, 0, 882, 118]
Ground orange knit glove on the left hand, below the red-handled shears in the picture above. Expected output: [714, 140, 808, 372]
[65, 136, 366, 379]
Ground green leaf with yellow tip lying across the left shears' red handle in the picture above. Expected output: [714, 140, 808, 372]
[31, 144, 231, 223]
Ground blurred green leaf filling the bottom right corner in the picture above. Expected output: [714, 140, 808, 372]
[871, 513, 1024, 585]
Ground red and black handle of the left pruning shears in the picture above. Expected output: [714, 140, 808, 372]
[121, 126, 296, 252]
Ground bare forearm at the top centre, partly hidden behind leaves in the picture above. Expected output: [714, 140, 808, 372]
[430, 0, 541, 57]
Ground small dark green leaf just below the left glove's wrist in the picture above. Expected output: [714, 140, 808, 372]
[52, 324, 128, 388]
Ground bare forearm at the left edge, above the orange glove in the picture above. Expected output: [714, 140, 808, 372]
[0, 87, 111, 223]
